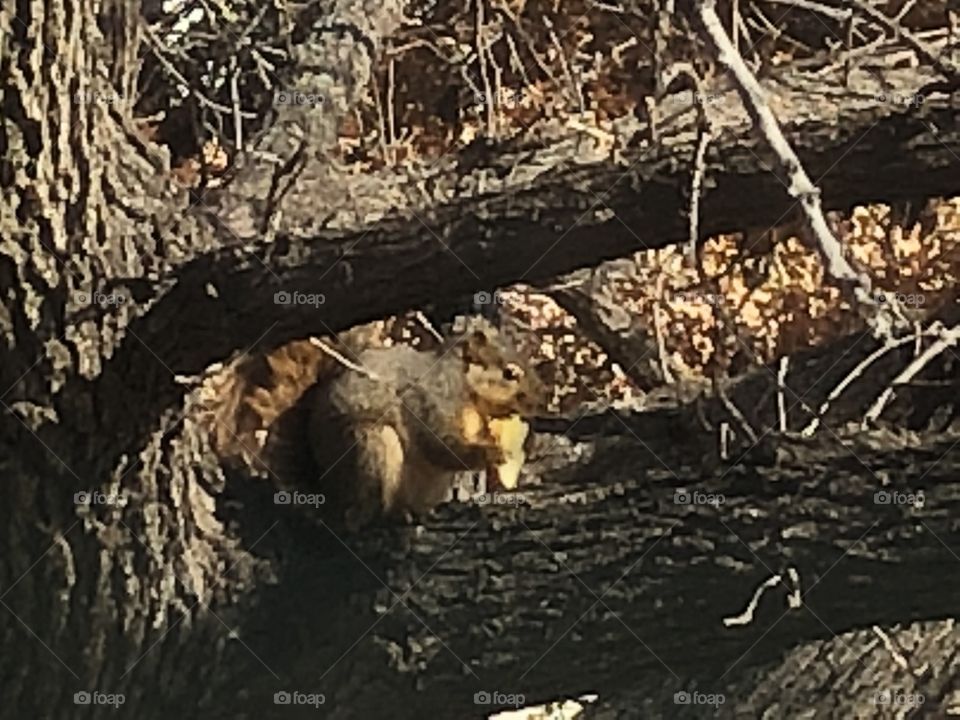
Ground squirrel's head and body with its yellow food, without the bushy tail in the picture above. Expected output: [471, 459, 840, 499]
[309, 321, 540, 528]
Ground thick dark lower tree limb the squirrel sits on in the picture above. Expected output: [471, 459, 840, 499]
[5, 435, 960, 720]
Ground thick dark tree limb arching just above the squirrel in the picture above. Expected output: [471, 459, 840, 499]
[127, 62, 960, 374]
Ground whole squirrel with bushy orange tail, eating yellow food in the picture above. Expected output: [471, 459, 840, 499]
[203, 318, 542, 529]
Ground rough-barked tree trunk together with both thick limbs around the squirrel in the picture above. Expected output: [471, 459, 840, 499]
[0, 0, 960, 720]
